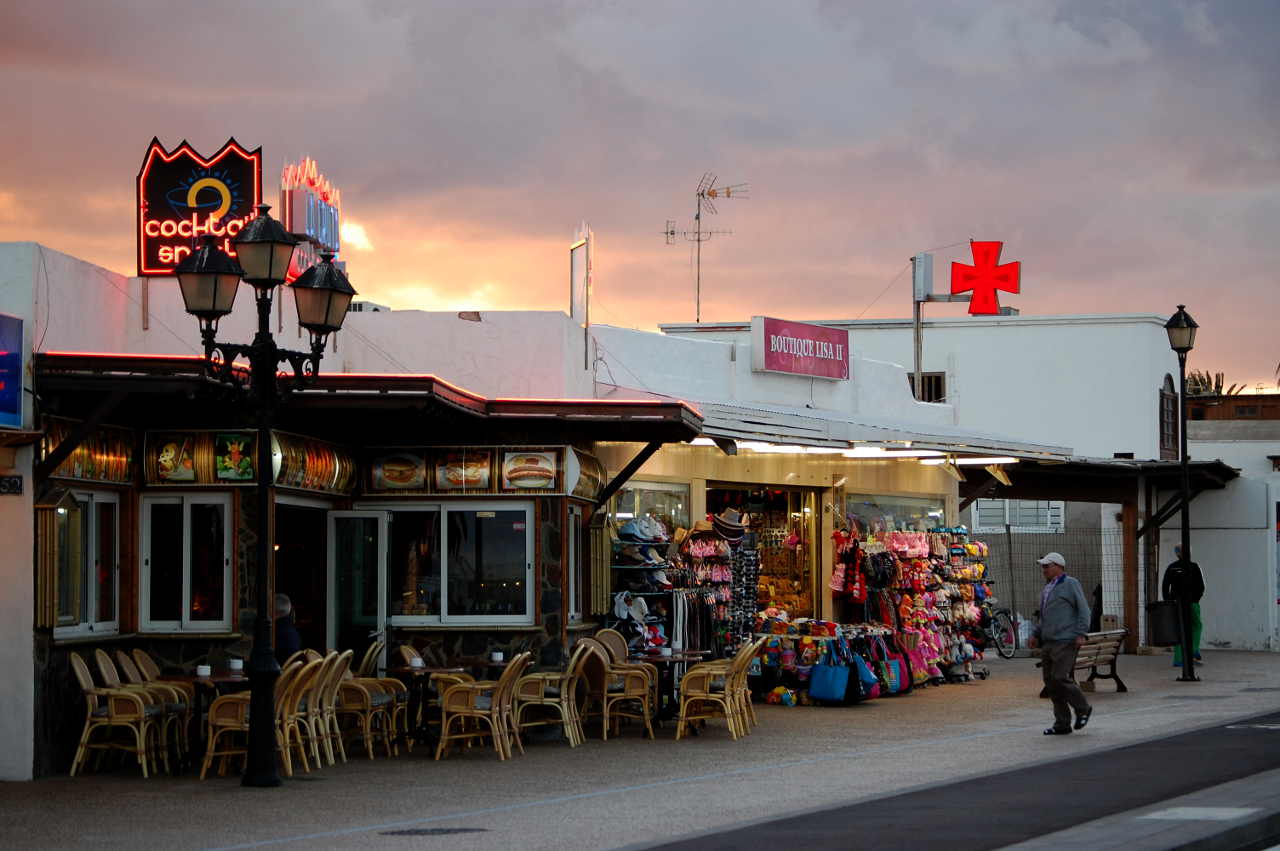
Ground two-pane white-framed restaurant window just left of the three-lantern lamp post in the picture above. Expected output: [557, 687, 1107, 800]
[138, 494, 232, 632]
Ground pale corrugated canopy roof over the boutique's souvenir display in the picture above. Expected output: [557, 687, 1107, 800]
[698, 402, 1071, 461]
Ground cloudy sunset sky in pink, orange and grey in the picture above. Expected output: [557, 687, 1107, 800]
[0, 0, 1280, 388]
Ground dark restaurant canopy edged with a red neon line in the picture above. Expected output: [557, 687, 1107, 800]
[33, 352, 703, 498]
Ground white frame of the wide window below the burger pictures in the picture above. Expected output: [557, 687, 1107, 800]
[357, 499, 536, 627]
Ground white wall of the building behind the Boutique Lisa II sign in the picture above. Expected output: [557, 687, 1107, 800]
[662, 313, 1178, 458]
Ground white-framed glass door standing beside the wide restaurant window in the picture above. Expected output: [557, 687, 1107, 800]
[326, 511, 388, 667]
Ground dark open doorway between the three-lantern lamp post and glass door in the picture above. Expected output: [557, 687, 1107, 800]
[275, 503, 328, 651]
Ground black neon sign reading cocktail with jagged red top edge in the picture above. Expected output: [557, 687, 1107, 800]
[138, 138, 262, 275]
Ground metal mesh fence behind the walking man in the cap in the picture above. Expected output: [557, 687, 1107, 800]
[973, 526, 1125, 630]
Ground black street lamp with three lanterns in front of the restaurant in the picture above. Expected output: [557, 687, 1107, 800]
[175, 203, 356, 786]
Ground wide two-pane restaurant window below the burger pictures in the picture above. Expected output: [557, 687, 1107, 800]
[387, 502, 534, 626]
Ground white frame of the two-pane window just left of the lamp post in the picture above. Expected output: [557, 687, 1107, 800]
[138, 493, 234, 633]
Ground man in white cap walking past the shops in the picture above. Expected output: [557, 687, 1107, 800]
[1030, 553, 1093, 736]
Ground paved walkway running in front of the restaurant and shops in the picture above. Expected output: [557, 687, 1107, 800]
[0, 651, 1280, 850]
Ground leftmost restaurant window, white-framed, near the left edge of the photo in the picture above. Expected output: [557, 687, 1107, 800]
[54, 491, 120, 637]
